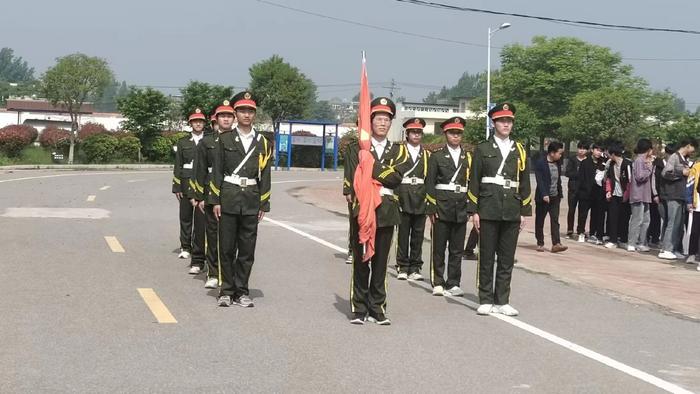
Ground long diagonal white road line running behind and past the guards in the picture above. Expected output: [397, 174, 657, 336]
[263, 217, 692, 394]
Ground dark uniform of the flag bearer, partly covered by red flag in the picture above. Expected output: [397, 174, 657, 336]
[344, 140, 407, 320]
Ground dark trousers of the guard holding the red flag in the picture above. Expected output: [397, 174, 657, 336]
[350, 222, 394, 317]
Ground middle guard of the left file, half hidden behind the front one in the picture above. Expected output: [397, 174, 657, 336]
[195, 103, 235, 289]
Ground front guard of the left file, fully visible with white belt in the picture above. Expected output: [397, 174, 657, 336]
[209, 91, 272, 307]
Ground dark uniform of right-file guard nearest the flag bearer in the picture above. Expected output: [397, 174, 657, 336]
[396, 146, 430, 275]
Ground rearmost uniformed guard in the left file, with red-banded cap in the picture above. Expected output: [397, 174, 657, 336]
[173, 108, 206, 275]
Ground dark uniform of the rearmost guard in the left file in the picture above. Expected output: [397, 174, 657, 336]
[172, 135, 205, 267]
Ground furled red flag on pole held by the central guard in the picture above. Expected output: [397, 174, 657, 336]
[353, 52, 382, 262]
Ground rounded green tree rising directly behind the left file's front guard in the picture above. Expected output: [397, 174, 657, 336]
[249, 55, 316, 124]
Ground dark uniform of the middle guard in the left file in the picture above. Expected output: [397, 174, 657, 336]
[194, 132, 219, 279]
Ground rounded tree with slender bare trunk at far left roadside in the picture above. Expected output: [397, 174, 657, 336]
[42, 53, 114, 164]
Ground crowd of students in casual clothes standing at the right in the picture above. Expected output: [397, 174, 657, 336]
[534, 138, 700, 270]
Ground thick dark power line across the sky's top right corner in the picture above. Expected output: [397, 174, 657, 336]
[395, 0, 700, 35]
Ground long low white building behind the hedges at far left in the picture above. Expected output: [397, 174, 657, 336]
[0, 98, 125, 133]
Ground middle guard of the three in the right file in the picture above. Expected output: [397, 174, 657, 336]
[426, 117, 472, 297]
